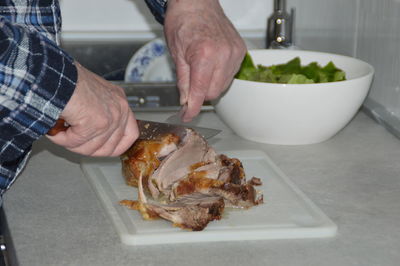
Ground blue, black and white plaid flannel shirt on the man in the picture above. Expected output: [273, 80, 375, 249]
[0, 0, 166, 195]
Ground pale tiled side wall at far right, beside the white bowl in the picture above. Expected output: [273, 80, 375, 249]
[356, 0, 400, 118]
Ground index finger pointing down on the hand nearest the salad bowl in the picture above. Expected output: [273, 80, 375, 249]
[182, 58, 214, 122]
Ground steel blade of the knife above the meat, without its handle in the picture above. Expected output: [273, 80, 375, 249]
[137, 120, 221, 139]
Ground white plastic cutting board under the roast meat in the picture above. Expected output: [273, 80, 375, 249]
[81, 150, 337, 245]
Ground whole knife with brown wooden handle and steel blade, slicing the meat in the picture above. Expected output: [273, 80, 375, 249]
[47, 118, 221, 139]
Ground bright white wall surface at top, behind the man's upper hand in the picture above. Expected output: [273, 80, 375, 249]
[61, 0, 272, 41]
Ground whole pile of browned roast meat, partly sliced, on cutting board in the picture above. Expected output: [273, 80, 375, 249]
[120, 129, 263, 231]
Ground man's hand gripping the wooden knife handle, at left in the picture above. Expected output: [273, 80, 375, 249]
[48, 63, 139, 156]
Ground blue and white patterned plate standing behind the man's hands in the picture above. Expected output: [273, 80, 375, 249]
[125, 38, 176, 82]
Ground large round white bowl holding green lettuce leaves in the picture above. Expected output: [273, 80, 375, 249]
[215, 49, 374, 145]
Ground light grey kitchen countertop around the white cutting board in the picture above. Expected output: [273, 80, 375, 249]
[4, 112, 400, 266]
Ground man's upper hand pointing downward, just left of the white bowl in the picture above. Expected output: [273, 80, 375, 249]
[164, 0, 246, 122]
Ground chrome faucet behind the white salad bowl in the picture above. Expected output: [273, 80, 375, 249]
[266, 0, 295, 49]
